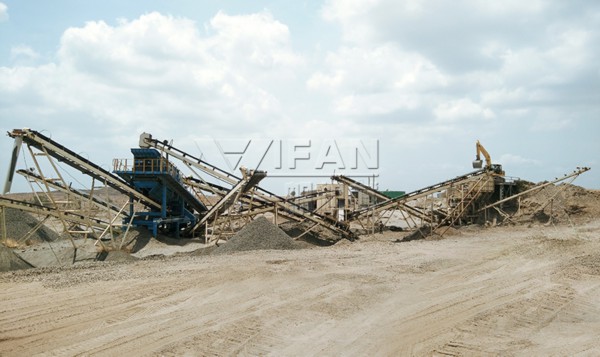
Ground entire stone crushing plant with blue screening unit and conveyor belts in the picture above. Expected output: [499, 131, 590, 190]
[0, 129, 589, 249]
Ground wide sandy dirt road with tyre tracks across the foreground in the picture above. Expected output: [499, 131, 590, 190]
[0, 223, 600, 356]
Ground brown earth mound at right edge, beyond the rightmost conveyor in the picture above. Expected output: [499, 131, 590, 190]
[515, 183, 600, 223]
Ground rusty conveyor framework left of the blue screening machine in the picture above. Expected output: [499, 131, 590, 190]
[1, 129, 141, 245]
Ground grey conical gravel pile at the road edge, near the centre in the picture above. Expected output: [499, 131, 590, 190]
[214, 217, 300, 254]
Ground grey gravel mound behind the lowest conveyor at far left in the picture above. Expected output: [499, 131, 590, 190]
[4, 208, 60, 243]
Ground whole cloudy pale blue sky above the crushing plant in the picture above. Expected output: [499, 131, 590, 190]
[0, 0, 600, 193]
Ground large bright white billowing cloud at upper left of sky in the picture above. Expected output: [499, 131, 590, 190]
[0, 12, 302, 136]
